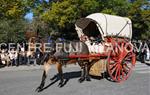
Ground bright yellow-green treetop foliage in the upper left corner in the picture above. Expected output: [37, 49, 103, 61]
[0, 0, 31, 19]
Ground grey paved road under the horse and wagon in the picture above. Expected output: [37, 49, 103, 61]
[0, 62, 150, 95]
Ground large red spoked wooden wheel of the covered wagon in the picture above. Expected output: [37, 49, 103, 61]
[107, 41, 135, 82]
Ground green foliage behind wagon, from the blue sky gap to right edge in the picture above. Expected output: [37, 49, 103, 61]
[24, 0, 150, 39]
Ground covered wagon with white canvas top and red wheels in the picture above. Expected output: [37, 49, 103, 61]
[70, 13, 136, 82]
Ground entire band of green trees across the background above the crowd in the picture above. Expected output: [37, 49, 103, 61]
[0, 0, 150, 42]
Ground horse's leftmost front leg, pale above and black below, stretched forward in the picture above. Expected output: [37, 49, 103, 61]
[36, 62, 50, 92]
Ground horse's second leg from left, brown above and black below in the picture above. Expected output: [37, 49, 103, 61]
[56, 62, 64, 87]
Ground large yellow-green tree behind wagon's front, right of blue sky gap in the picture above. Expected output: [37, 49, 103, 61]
[40, 0, 99, 37]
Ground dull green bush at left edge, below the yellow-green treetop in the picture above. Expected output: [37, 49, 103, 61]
[0, 19, 26, 42]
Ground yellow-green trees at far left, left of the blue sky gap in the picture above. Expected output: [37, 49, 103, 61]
[0, 0, 36, 42]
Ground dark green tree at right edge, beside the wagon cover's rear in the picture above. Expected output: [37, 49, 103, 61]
[128, 0, 150, 39]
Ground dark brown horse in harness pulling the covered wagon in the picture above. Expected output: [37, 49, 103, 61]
[36, 41, 90, 92]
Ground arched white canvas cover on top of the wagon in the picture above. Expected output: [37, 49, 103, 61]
[75, 13, 132, 39]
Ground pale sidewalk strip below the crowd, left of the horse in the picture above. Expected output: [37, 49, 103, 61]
[0, 65, 43, 72]
